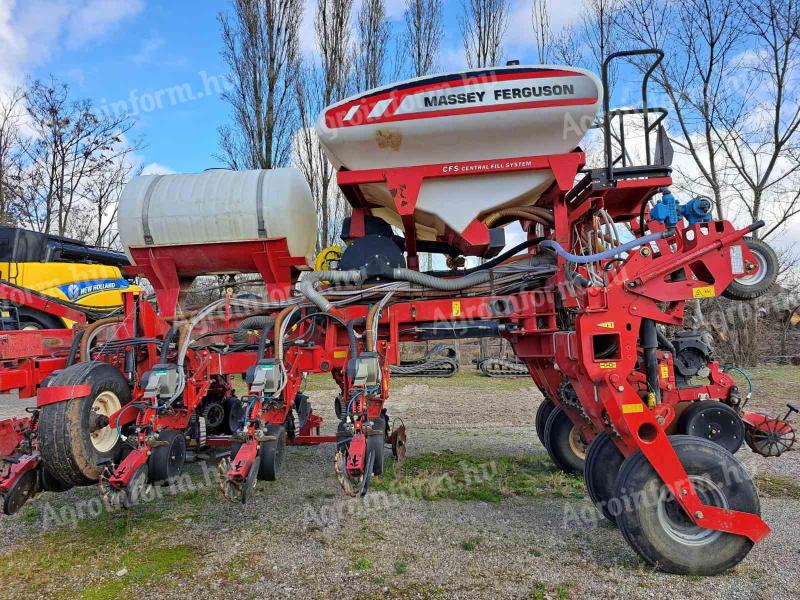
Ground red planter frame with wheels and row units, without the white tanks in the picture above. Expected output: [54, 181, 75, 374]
[0, 51, 794, 574]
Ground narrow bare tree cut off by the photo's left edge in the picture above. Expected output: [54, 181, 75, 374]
[0, 88, 25, 224]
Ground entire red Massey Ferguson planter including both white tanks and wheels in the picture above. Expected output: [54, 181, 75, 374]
[0, 50, 795, 575]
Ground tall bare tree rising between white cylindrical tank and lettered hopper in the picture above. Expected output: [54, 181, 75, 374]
[294, 0, 353, 249]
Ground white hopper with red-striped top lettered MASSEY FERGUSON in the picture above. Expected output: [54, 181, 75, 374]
[317, 65, 603, 240]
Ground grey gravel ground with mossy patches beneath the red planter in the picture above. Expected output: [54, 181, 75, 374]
[0, 377, 800, 599]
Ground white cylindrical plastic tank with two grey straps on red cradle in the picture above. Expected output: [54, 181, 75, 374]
[117, 168, 317, 259]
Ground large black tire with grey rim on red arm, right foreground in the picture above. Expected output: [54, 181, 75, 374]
[616, 435, 761, 575]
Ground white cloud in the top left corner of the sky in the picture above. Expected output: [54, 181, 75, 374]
[0, 0, 144, 90]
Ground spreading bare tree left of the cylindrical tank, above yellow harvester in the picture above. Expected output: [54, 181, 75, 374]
[19, 79, 141, 235]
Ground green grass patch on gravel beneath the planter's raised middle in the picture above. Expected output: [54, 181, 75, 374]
[371, 452, 584, 502]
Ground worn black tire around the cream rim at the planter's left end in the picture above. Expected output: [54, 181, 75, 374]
[39, 361, 131, 485]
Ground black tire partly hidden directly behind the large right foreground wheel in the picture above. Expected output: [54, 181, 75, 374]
[583, 432, 625, 525]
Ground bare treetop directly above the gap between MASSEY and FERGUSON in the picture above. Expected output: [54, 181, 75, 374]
[460, 0, 509, 68]
